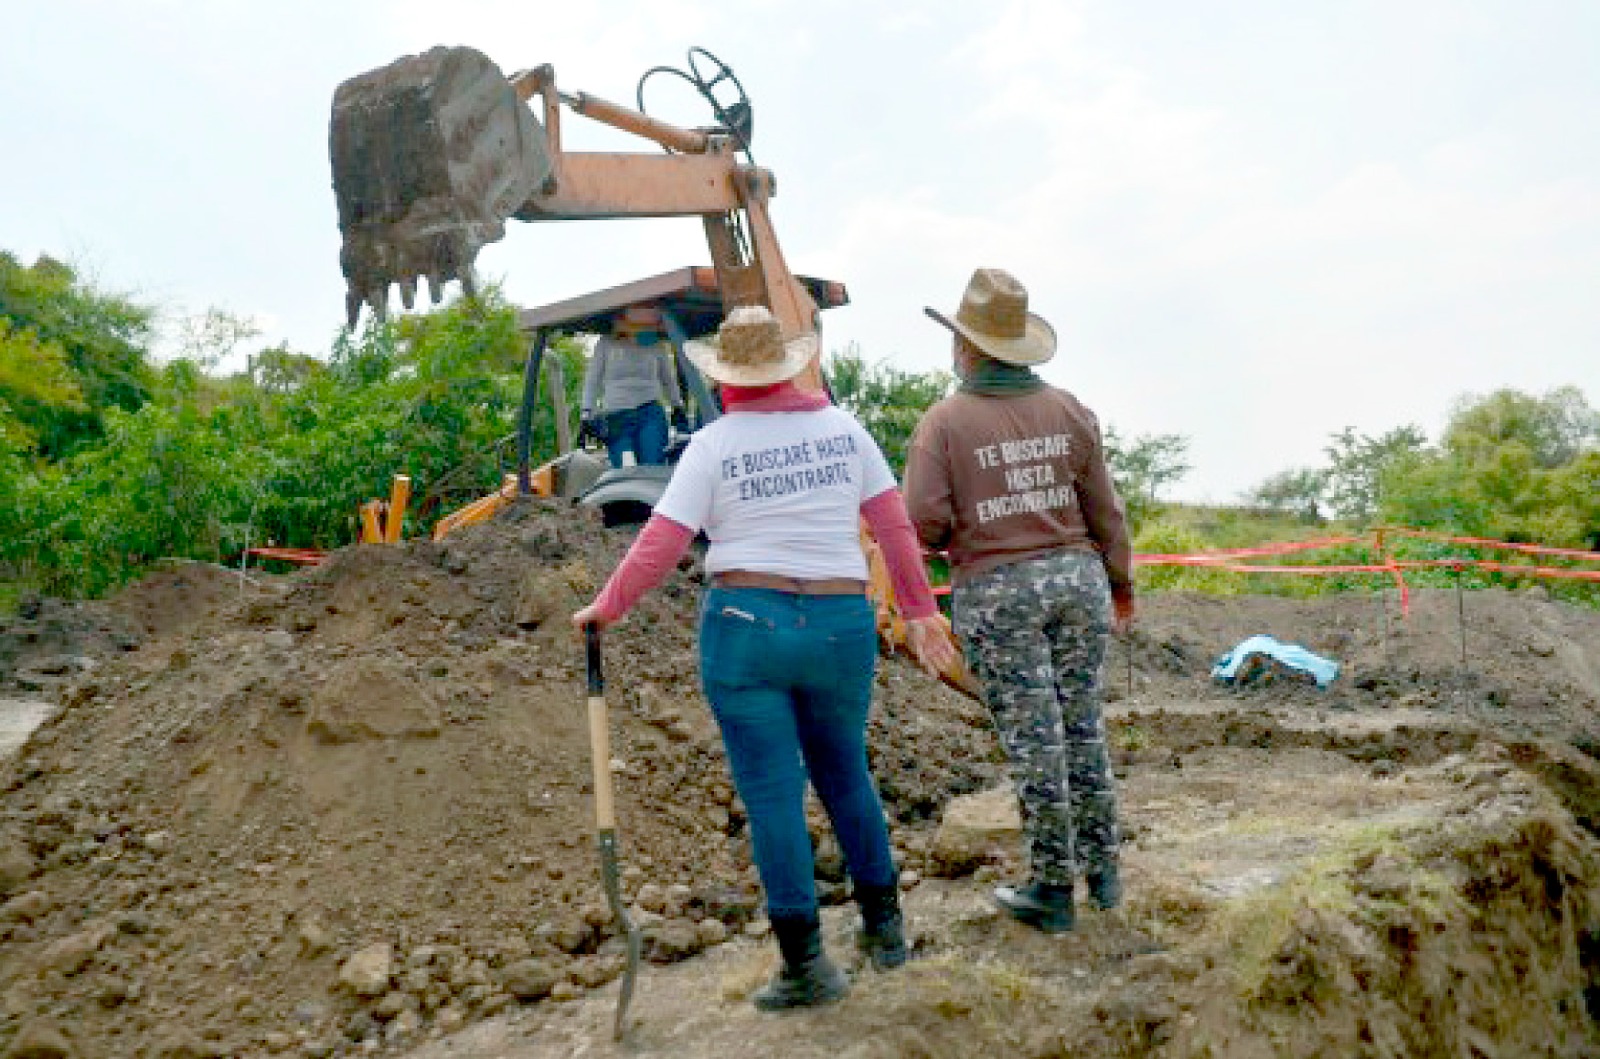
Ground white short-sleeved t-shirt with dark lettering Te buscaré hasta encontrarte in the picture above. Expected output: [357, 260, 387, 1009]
[656, 405, 896, 579]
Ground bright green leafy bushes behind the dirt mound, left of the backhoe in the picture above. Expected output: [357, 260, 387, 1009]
[0, 290, 582, 595]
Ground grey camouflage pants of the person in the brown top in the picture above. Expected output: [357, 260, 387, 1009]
[954, 550, 1120, 886]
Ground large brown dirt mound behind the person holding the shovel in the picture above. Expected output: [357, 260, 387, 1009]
[0, 502, 998, 1057]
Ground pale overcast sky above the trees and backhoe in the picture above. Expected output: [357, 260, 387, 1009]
[0, 0, 1600, 501]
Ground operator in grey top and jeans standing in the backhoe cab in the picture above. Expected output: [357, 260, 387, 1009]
[582, 306, 688, 467]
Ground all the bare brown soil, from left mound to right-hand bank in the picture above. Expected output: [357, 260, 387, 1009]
[0, 502, 1600, 1059]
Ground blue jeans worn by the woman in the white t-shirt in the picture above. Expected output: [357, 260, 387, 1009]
[699, 587, 896, 917]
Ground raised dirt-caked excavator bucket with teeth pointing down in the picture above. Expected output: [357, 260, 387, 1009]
[328, 48, 552, 326]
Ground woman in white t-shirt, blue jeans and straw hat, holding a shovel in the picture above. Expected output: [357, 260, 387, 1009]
[573, 307, 955, 1011]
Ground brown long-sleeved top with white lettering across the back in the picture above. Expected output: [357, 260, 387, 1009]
[906, 386, 1133, 595]
